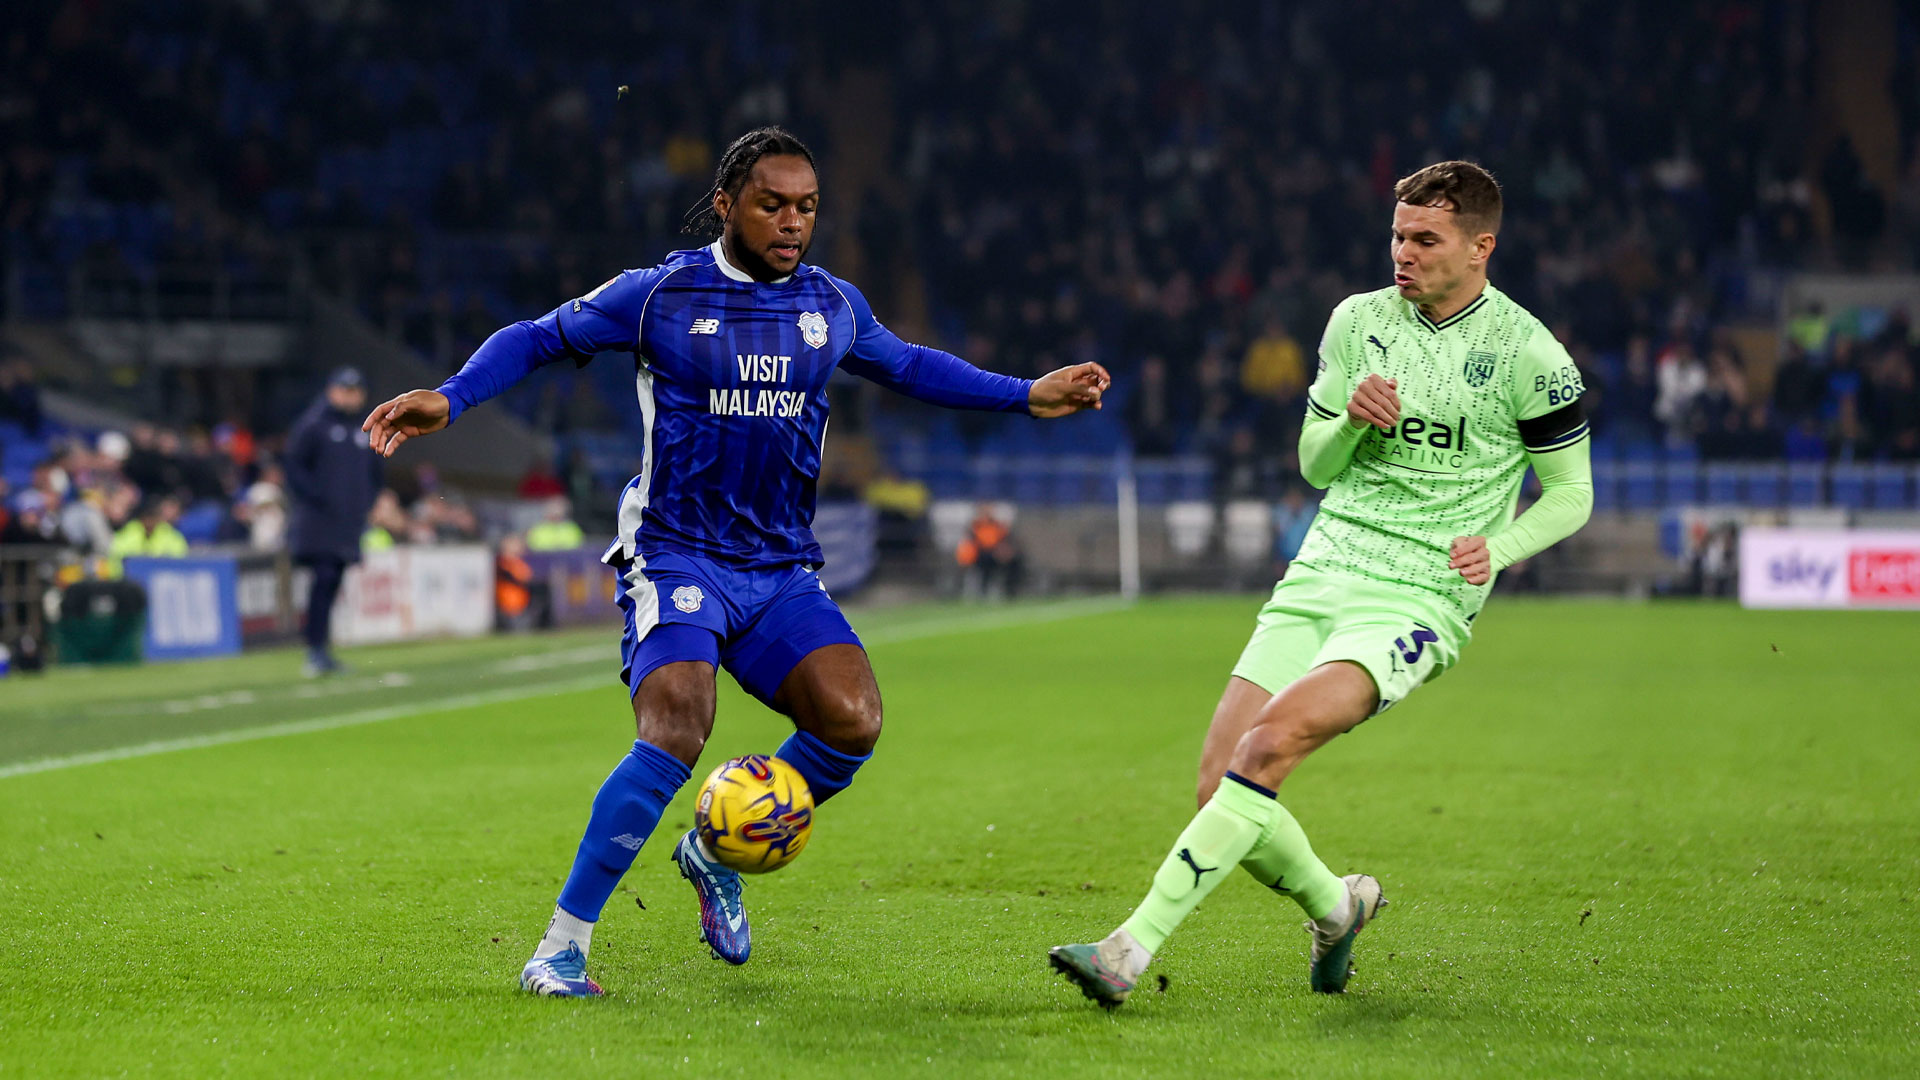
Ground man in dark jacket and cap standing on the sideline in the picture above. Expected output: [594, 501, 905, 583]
[282, 367, 382, 676]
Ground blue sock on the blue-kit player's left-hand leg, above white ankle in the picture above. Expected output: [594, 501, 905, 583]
[561, 740, 691, 922]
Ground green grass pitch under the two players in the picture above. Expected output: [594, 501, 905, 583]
[0, 598, 1920, 1078]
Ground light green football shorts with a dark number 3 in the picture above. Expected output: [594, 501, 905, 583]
[1233, 563, 1473, 715]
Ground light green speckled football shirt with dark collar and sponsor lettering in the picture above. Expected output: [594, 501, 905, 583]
[1298, 284, 1586, 623]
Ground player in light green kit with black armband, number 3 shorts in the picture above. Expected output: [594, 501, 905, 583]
[1050, 161, 1594, 1009]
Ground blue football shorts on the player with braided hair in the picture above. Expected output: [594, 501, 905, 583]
[611, 553, 864, 705]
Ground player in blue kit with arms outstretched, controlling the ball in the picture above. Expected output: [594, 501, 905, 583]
[363, 127, 1110, 997]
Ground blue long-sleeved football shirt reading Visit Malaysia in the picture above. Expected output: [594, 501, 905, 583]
[440, 242, 1031, 569]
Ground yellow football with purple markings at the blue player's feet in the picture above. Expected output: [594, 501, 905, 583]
[693, 753, 814, 874]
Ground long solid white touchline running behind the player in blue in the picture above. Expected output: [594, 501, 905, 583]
[0, 598, 1131, 780]
